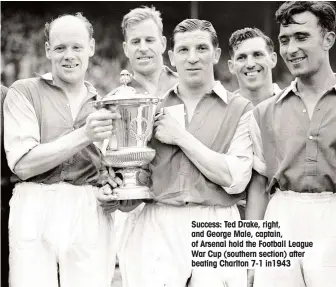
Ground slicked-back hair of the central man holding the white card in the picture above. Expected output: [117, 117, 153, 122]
[170, 19, 219, 49]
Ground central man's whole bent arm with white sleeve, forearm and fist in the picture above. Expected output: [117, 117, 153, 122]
[154, 112, 252, 193]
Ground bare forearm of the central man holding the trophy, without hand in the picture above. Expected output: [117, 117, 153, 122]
[176, 132, 232, 186]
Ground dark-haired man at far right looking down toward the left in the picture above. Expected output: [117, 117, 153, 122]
[251, 1, 336, 287]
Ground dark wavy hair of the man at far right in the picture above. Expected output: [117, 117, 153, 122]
[275, 1, 336, 34]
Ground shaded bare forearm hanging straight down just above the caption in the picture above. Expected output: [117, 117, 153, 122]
[246, 170, 269, 220]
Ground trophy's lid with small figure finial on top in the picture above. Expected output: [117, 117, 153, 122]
[101, 70, 159, 103]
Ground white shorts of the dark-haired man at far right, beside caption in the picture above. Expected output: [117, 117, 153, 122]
[253, 191, 336, 287]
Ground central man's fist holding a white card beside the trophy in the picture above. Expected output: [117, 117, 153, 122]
[153, 112, 185, 145]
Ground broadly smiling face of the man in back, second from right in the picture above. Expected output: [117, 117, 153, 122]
[228, 37, 277, 91]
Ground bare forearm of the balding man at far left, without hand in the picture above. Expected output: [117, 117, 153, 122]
[14, 127, 91, 180]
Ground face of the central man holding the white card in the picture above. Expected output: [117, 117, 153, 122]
[168, 30, 221, 87]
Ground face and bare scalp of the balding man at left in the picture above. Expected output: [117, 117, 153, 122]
[46, 17, 94, 84]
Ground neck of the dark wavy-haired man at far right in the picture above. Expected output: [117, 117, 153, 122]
[297, 64, 336, 95]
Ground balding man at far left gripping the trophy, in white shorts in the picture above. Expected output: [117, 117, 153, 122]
[4, 14, 120, 287]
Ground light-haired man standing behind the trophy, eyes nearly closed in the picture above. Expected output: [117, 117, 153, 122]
[121, 6, 177, 98]
